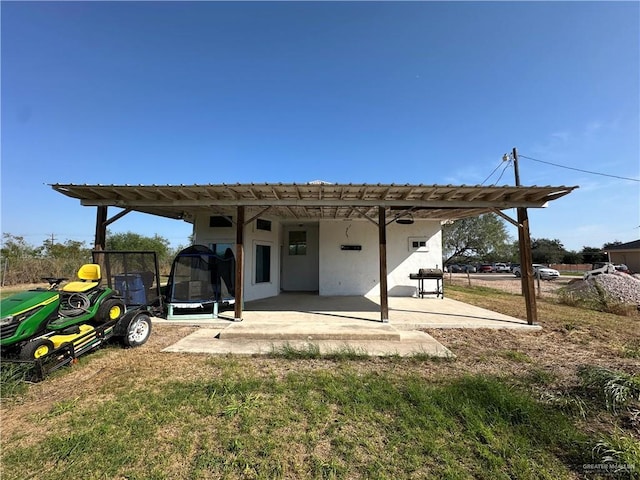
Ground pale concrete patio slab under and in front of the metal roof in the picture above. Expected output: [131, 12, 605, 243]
[158, 294, 541, 357]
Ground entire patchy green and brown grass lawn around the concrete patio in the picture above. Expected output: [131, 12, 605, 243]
[0, 287, 640, 480]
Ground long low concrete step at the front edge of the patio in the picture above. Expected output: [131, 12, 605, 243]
[219, 322, 401, 342]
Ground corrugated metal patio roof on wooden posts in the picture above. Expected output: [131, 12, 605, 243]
[50, 182, 578, 221]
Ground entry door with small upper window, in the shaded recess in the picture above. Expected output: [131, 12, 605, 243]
[282, 223, 320, 292]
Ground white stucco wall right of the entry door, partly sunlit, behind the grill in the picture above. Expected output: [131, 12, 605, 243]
[320, 220, 442, 296]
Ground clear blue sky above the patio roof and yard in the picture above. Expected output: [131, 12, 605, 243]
[0, 1, 640, 250]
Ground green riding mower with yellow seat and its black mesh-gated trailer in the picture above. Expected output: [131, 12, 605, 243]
[0, 251, 163, 379]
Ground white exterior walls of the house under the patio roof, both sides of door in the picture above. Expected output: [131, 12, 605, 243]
[194, 215, 442, 301]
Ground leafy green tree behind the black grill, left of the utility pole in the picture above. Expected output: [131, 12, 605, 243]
[442, 213, 511, 264]
